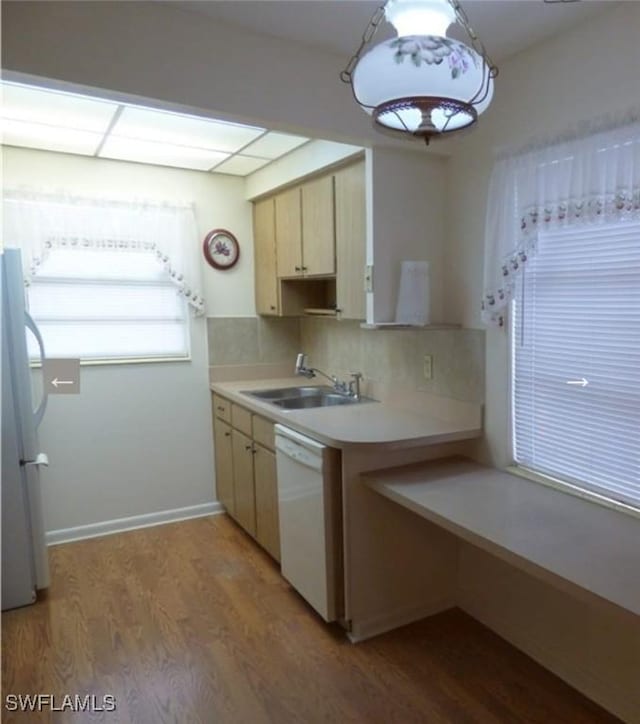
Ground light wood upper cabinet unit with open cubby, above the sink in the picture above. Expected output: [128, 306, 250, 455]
[254, 161, 366, 319]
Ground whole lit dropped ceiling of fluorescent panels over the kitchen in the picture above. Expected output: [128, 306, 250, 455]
[1, 82, 309, 176]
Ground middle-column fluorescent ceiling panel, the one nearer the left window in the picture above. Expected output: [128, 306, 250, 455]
[100, 136, 229, 171]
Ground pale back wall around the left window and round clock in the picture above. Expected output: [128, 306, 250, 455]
[3, 147, 253, 531]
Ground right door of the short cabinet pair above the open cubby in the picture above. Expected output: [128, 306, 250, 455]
[302, 176, 336, 276]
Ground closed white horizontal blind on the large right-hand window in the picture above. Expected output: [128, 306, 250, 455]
[512, 222, 640, 506]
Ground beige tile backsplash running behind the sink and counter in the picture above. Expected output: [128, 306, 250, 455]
[207, 317, 485, 404]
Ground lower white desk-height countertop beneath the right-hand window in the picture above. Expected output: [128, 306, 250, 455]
[363, 458, 640, 615]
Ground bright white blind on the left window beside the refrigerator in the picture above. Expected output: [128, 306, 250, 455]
[27, 249, 189, 360]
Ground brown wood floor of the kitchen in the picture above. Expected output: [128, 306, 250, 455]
[2, 516, 617, 724]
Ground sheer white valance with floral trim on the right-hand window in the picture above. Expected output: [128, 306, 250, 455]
[482, 123, 640, 326]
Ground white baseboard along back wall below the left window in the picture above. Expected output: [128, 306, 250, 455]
[45, 502, 224, 546]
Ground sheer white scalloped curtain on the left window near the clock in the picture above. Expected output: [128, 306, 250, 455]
[3, 190, 205, 315]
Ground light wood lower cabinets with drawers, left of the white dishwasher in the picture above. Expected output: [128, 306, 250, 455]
[212, 395, 280, 561]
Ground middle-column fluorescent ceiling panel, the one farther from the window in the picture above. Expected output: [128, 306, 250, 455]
[111, 107, 265, 153]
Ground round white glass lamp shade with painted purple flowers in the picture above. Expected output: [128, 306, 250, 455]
[352, 35, 493, 136]
